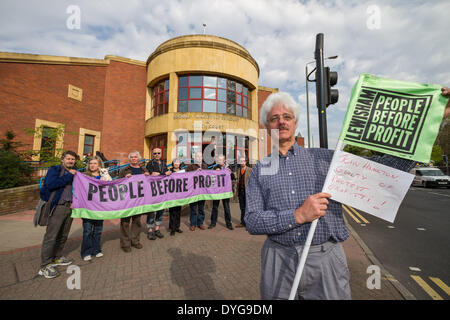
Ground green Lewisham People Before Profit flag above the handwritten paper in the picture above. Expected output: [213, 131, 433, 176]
[339, 73, 448, 162]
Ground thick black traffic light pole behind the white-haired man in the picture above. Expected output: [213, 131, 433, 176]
[314, 33, 328, 148]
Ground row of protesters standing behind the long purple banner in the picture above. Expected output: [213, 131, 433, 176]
[39, 147, 251, 278]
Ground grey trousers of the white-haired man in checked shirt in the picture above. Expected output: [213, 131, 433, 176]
[260, 238, 351, 300]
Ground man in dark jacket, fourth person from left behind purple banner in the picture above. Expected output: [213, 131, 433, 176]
[147, 148, 172, 240]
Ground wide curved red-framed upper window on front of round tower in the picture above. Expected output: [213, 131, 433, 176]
[178, 75, 250, 118]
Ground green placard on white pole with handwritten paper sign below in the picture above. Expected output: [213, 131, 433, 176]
[289, 73, 448, 300]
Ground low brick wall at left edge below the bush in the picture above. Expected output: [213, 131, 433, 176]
[0, 184, 39, 216]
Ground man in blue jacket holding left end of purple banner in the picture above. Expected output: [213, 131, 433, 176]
[38, 151, 77, 278]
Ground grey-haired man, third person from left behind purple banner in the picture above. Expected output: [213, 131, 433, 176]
[119, 151, 149, 252]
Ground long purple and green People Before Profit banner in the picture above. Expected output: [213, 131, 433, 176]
[72, 170, 233, 220]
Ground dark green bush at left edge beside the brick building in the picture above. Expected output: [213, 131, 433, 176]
[0, 131, 33, 189]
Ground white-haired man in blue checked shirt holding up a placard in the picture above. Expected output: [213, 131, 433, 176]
[245, 88, 450, 299]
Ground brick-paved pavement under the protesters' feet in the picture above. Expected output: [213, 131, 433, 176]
[0, 201, 414, 300]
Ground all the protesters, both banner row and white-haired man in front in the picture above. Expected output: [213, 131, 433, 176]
[34, 87, 450, 299]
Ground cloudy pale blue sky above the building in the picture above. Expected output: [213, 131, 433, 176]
[0, 0, 450, 149]
